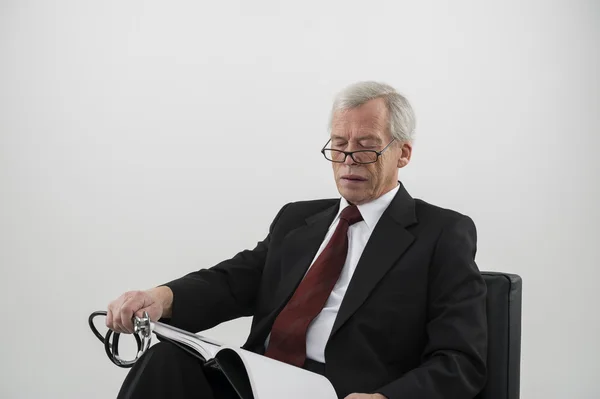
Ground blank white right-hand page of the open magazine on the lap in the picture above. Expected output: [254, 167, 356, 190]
[224, 347, 337, 399]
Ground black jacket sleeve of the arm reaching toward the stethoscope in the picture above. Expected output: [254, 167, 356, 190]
[163, 204, 289, 332]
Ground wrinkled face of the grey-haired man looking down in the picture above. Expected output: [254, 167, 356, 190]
[328, 98, 411, 205]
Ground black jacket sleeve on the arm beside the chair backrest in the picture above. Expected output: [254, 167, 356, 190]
[376, 216, 487, 399]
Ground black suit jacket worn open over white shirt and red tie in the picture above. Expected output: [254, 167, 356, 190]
[166, 186, 487, 399]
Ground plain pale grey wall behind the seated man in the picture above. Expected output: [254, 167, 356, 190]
[0, 0, 600, 399]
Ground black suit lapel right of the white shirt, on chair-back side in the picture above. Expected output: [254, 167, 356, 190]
[329, 185, 417, 339]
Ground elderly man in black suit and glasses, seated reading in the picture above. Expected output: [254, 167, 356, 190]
[107, 82, 487, 399]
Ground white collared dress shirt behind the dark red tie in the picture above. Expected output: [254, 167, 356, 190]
[265, 186, 400, 363]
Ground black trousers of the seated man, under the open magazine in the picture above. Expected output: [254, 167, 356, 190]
[117, 342, 325, 399]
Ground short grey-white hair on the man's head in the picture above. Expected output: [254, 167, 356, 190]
[329, 81, 416, 142]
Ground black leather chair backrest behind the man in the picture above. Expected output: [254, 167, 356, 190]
[477, 272, 522, 399]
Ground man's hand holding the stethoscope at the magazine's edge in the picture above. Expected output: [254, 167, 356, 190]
[106, 286, 173, 334]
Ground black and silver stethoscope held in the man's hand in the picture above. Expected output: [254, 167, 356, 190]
[88, 311, 153, 368]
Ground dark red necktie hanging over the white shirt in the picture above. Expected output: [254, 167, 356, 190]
[265, 205, 362, 367]
